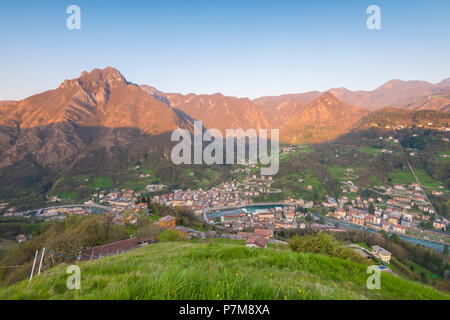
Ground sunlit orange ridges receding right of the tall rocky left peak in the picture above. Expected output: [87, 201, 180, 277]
[141, 74, 450, 142]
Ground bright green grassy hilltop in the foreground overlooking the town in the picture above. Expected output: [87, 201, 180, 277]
[0, 239, 450, 300]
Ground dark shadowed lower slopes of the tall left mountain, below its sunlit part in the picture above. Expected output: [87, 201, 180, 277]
[0, 122, 181, 208]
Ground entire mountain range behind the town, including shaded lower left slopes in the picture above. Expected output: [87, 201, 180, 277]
[0, 67, 450, 207]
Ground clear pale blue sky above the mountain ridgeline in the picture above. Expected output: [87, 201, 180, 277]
[0, 0, 450, 100]
